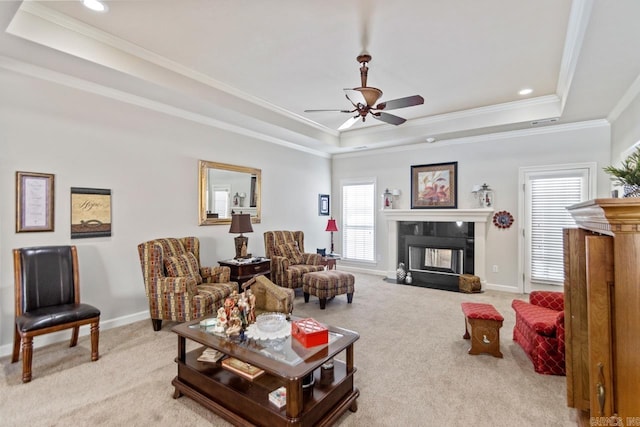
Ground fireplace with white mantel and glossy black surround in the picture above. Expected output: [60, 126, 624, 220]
[382, 208, 493, 291]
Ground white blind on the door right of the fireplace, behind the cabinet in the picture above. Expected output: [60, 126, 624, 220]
[529, 176, 585, 285]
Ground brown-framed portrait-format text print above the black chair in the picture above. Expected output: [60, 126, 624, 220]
[16, 171, 54, 233]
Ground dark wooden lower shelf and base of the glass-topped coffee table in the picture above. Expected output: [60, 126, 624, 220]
[172, 349, 360, 426]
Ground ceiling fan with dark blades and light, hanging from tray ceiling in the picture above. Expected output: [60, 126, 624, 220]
[304, 53, 424, 130]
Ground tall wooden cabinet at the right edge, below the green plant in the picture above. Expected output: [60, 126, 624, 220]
[564, 198, 640, 425]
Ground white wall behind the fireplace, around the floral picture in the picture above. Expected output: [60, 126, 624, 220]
[332, 121, 610, 292]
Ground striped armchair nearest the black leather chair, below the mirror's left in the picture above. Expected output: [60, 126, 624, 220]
[138, 237, 238, 331]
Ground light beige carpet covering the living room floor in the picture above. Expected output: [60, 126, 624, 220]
[0, 274, 576, 427]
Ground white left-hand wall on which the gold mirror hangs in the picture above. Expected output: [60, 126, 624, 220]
[0, 70, 331, 355]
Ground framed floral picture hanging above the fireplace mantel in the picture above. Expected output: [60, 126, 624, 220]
[411, 162, 458, 209]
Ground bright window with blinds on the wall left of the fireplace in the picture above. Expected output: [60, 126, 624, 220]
[342, 182, 376, 261]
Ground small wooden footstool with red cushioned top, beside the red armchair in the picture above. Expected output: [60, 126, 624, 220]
[461, 302, 504, 357]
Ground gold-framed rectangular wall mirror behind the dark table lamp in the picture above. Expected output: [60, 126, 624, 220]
[198, 160, 262, 225]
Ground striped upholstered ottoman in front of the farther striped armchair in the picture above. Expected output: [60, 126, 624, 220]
[302, 270, 355, 310]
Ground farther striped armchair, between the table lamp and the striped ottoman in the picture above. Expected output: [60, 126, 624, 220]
[264, 231, 324, 289]
